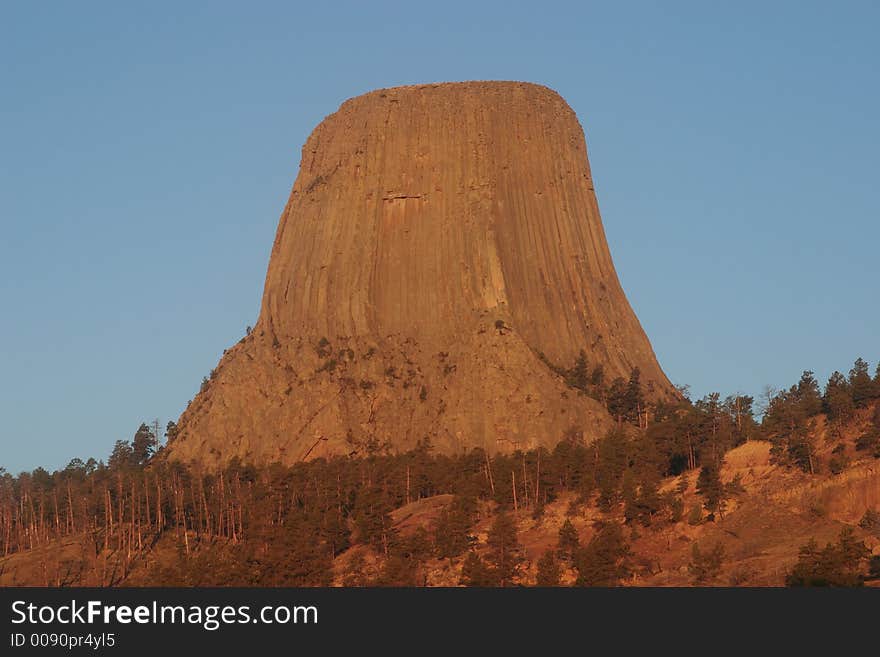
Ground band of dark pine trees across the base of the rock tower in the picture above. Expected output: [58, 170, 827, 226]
[0, 359, 880, 585]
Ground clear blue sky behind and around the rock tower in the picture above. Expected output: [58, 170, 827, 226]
[0, 0, 880, 472]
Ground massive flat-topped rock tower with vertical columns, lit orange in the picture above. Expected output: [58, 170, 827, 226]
[167, 82, 674, 465]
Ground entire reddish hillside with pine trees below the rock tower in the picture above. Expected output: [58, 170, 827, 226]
[0, 359, 880, 586]
